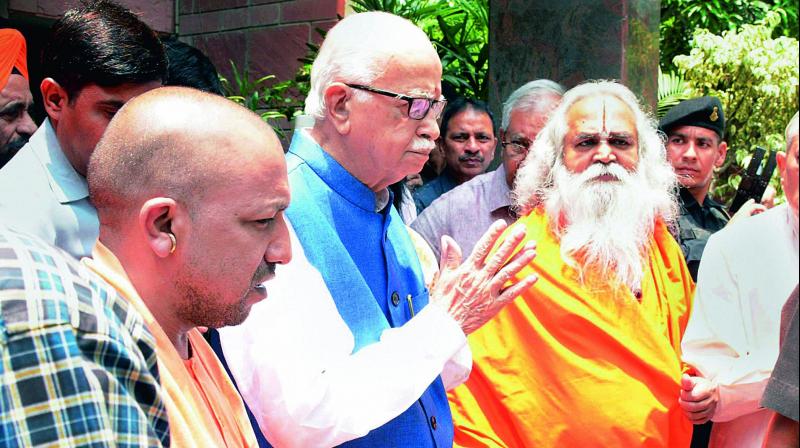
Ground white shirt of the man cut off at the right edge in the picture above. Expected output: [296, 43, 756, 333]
[681, 204, 798, 448]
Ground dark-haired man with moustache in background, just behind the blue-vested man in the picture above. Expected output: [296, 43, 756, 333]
[414, 98, 497, 213]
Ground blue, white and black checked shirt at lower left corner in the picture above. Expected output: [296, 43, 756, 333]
[0, 226, 169, 447]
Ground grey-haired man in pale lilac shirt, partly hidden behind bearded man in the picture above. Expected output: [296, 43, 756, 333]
[411, 79, 564, 257]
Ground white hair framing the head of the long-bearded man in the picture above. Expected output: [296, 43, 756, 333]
[513, 80, 676, 221]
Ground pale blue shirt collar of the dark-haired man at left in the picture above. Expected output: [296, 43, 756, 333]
[29, 118, 89, 204]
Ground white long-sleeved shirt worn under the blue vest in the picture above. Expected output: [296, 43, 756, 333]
[219, 221, 472, 447]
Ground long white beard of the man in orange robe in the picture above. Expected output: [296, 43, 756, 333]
[542, 163, 673, 291]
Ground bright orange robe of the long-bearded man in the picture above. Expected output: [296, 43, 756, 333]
[449, 209, 694, 447]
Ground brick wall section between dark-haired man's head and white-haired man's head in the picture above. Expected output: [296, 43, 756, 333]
[175, 0, 345, 80]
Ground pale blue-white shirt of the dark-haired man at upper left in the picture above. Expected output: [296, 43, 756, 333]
[0, 119, 100, 258]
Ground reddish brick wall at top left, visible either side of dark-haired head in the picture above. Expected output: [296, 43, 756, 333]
[8, 0, 345, 86]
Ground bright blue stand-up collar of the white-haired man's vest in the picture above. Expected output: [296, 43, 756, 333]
[289, 129, 390, 212]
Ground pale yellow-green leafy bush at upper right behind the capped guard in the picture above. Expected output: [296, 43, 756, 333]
[675, 12, 800, 201]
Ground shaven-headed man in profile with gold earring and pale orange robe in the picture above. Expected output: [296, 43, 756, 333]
[85, 87, 291, 447]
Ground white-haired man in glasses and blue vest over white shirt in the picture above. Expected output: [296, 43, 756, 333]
[212, 12, 536, 447]
